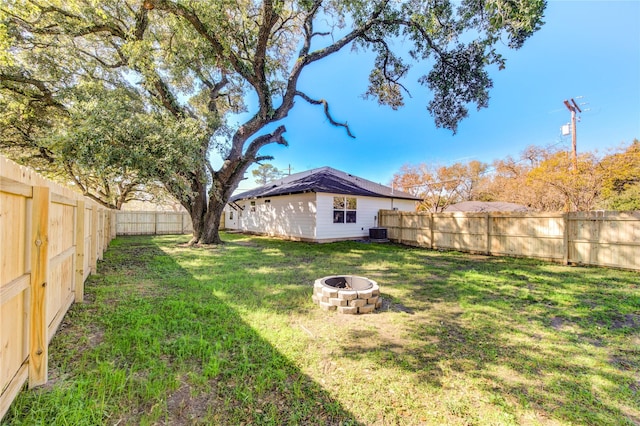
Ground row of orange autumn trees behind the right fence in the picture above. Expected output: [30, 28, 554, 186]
[392, 140, 640, 212]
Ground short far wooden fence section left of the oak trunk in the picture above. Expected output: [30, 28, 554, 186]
[116, 210, 193, 235]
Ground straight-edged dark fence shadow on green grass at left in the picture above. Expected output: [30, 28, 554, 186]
[5, 238, 359, 425]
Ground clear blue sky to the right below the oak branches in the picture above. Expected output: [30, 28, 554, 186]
[228, 0, 640, 190]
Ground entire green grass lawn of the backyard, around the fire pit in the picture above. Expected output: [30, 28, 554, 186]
[3, 234, 640, 425]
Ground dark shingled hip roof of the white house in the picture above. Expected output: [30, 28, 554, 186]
[230, 167, 419, 202]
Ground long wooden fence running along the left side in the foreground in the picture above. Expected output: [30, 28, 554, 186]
[0, 157, 115, 419]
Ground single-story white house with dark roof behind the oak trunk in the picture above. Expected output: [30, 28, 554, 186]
[225, 167, 419, 242]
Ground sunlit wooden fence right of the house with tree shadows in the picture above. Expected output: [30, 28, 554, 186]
[379, 210, 640, 270]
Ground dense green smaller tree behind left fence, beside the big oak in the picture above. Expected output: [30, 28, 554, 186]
[0, 76, 189, 209]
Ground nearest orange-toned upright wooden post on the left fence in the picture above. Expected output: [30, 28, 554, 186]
[29, 186, 50, 388]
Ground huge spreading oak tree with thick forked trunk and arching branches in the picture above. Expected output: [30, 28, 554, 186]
[0, 0, 545, 243]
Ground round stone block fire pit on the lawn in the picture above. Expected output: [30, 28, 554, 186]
[311, 275, 382, 314]
